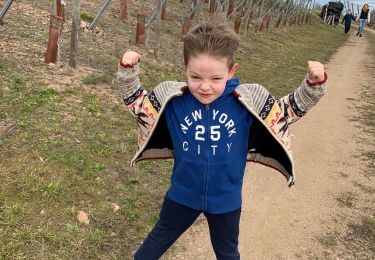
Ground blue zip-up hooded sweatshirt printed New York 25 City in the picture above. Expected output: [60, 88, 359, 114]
[165, 78, 253, 214]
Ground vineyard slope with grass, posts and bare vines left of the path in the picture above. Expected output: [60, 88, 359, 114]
[0, 0, 370, 259]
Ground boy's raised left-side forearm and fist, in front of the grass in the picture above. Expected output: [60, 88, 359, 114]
[117, 52, 147, 116]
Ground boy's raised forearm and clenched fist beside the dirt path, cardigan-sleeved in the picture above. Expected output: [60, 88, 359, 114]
[278, 61, 327, 124]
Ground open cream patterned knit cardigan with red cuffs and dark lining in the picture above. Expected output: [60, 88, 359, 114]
[117, 65, 327, 186]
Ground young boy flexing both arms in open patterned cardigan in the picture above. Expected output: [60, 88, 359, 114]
[117, 23, 327, 260]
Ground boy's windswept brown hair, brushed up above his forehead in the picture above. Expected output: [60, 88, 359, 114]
[182, 22, 240, 69]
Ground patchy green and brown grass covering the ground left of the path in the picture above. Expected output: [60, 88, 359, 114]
[0, 1, 352, 259]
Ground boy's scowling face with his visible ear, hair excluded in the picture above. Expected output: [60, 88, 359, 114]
[186, 54, 238, 105]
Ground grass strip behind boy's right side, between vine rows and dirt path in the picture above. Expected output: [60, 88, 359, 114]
[237, 17, 347, 97]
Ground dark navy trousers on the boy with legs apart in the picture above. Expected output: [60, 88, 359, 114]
[134, 197, 241, 260]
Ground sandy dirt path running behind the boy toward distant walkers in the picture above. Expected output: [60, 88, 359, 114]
[164, 30, 369, 260]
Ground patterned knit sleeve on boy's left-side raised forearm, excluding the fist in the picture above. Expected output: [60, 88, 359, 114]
[117, 65, 147, 117]
